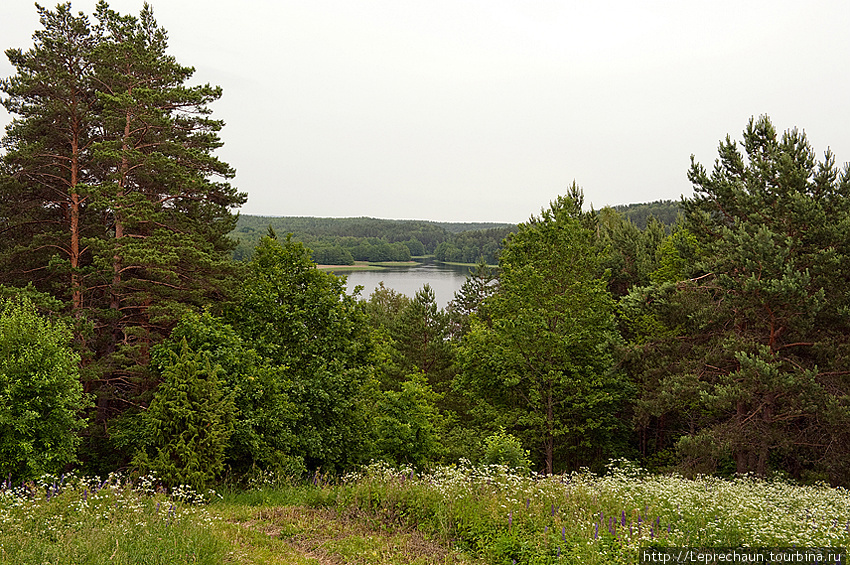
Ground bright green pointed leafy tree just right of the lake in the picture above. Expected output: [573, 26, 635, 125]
[456, 187, 626, 473]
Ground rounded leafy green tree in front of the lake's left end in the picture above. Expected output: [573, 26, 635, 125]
[228, 237, 372, 468]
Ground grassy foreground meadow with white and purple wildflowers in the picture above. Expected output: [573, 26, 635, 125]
[0, 464, 850, 565]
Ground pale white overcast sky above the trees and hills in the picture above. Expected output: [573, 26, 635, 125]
[0, 0, 850, 222]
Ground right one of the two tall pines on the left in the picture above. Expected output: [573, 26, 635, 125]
[84, 1, 244, 386]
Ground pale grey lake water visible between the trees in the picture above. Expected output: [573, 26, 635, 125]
[336, 261, 469, 308]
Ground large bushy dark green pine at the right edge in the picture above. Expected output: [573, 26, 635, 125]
[629, 117, 850, 482]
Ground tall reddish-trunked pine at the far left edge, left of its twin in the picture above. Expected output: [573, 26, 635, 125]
[0, 4, 100, 316]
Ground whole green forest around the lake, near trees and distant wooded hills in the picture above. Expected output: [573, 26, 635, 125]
[0, 2, 850, 487]
